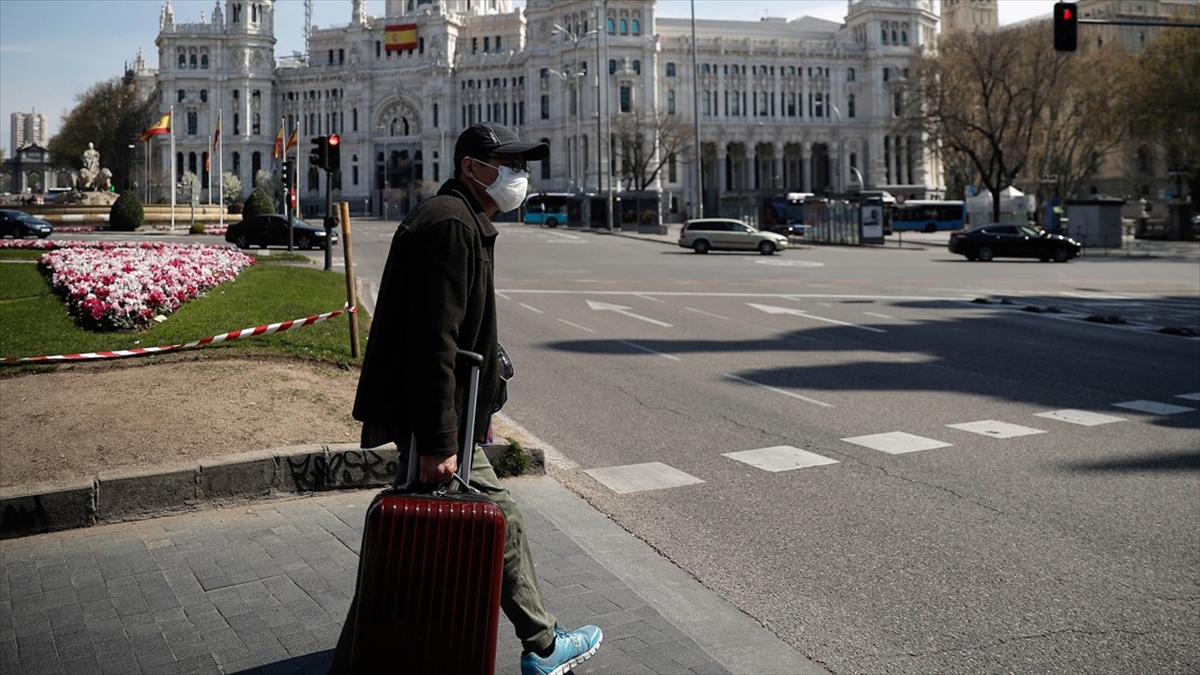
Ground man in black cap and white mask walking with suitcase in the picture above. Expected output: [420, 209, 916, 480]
[330, 123, 602, 675]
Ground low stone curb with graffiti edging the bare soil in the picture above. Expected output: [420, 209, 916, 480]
[0, 443, 546, 539]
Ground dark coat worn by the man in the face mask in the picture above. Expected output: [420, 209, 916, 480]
[354, 179, 499, 455]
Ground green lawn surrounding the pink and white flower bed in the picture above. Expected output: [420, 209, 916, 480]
[0, 251, 370, 365]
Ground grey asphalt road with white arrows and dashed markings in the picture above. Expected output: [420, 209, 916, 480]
[77, 221, 1200, 674]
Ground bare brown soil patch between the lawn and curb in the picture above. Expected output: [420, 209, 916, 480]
[0, 354, 361, 486]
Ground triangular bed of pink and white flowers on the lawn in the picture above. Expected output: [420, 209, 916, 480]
[29, 241, 254, 330]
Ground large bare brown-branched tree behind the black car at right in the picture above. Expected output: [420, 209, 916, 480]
[898, 24, 1066, 219]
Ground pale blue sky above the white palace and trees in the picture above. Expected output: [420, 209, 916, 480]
[0, 0, 1054, 152]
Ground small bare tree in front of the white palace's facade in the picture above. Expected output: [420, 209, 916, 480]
[612, 110, 695, 190]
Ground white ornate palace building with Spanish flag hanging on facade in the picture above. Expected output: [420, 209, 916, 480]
[134, 0, 974, 215]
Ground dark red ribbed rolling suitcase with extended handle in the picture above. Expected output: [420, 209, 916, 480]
[350, 352, 505, 675]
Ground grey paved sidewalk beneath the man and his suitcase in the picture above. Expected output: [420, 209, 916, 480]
[0, 477, 822, 675]
